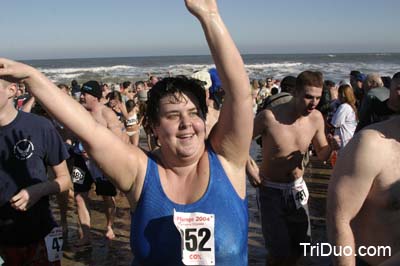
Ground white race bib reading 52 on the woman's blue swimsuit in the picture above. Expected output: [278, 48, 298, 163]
[174, 209, 215, 265]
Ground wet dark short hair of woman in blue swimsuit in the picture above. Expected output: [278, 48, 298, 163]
[147, 76, 208, 125]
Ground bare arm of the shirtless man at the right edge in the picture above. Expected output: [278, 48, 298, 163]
[327, 130, 384, 266]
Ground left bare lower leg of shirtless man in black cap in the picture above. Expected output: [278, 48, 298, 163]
[75, 192, 90, 245]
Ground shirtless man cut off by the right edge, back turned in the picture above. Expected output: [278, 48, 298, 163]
[327, 72, 400, 265]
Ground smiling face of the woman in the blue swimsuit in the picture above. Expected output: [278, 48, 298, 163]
[153, 93, 206, 159]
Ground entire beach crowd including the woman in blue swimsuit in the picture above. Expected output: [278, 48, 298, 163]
[0, 0, 400, 265]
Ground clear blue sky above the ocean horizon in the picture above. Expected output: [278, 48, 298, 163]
[0, 0, 400, 59]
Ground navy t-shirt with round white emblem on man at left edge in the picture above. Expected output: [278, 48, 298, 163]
[0, 112, 68, 245]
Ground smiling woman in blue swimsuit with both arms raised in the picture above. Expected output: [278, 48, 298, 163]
[0, 0, 253, 265]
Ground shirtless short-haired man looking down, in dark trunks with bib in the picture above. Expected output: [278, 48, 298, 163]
[248, 71, 331, 265]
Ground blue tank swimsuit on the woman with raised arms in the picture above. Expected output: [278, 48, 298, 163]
[131, 146, 248, 266]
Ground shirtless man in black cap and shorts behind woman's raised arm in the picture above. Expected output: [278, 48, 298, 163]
[72, 81, 128, 245]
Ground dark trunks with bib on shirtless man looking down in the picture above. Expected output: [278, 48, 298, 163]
[259, 178, 311, 257]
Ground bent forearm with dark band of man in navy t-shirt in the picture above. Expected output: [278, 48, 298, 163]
[10, 161, 72, 211]
